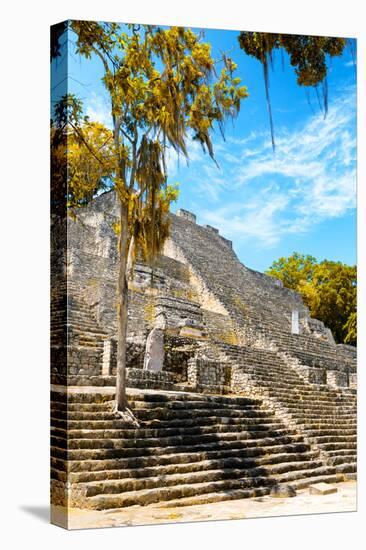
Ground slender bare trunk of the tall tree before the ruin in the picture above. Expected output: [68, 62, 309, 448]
[116, 199, 128, 411]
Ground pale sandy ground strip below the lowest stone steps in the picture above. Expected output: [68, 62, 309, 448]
[51, 481, 357, 529]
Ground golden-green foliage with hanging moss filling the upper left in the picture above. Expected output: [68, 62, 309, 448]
[60, 21, 248, 274]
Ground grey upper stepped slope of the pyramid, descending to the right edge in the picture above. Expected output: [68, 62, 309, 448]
[167, 212, 356, 380]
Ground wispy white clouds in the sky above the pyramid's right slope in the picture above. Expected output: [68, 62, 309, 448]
[172, 88, 356, 247]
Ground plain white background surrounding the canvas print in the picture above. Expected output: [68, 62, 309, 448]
[1, 0, 366, 550]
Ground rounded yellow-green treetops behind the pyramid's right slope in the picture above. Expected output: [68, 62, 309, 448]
[266, 252, 357, 345]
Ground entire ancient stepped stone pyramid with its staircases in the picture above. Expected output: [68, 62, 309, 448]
[51, 192, 356, 509]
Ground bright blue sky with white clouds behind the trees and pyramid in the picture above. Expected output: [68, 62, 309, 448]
[56, 23, 356, 271]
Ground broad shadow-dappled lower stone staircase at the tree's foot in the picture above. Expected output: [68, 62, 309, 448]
[51, 388, 343, 510]
